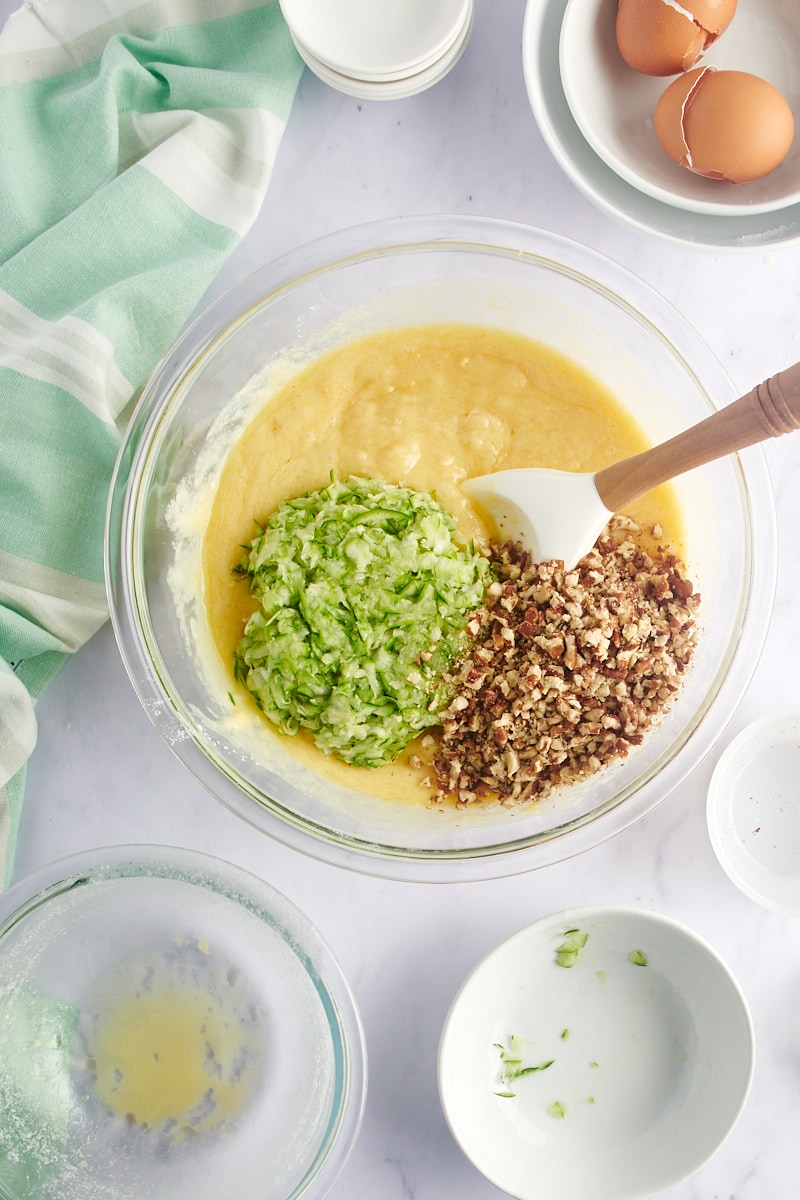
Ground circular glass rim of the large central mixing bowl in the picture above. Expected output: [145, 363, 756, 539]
[106, 214, 777, 882]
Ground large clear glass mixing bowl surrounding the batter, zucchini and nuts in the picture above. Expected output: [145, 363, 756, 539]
[107, 216, 777, 881]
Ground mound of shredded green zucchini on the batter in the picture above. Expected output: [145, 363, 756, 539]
[235, 476, 489, 767]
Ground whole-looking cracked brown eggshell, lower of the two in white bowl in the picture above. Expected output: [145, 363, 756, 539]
[654, 66, 794, 184]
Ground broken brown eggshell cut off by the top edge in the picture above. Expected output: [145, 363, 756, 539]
[616, 0, 736, 76]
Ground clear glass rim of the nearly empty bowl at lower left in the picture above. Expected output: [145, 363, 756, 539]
[0, 842, 367, 1200]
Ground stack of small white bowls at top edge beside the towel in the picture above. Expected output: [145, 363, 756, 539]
[281, 0, 474, 100]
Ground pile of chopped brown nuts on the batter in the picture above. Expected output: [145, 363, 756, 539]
[433, 516, 699, 805]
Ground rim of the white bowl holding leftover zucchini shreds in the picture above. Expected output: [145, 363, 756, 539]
[437, 904, 756, 1200]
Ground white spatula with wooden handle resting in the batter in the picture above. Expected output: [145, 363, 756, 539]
[462, 362, 800, 569]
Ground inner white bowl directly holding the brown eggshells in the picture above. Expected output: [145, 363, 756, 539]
[559, 0, 800, 215]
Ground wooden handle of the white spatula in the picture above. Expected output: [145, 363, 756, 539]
[595, 362, 800, 512]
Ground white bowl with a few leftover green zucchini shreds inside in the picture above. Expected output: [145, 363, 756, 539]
[439, 906, 754, 1200]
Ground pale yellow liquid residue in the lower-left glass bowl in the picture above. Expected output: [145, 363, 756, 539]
[90, 964, 258, 1138]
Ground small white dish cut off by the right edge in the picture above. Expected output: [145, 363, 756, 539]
[706, 707, 800, 917]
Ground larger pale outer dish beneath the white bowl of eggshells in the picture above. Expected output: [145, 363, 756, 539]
[522, 0, 800, 252]
